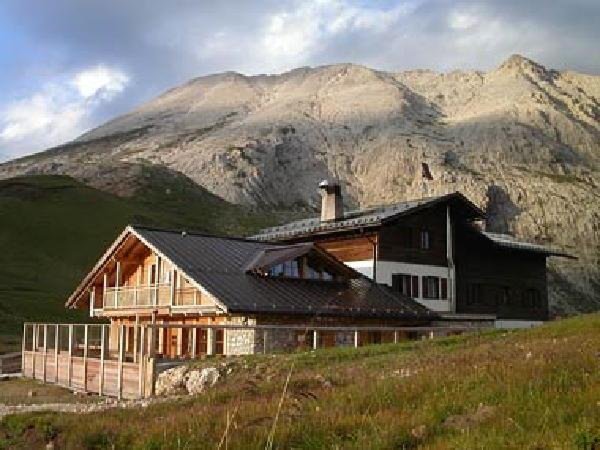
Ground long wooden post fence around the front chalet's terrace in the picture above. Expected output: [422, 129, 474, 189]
[22, 323, 479, 398]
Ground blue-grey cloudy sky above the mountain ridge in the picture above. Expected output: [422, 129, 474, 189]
[0, 0, 600, 161]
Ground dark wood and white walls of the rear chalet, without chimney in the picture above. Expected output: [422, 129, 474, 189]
[271, 195, 549, 322]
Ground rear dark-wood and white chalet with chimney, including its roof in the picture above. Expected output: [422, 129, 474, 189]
[253, 181, 568, 327]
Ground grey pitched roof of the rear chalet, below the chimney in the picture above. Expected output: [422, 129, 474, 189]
[251, 192, 484, 241]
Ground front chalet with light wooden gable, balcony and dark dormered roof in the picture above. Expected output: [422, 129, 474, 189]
[67, 226, 436, 358]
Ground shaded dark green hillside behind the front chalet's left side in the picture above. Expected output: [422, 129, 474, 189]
[0, 172, 273, 353]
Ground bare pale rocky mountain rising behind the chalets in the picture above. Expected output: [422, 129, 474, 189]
[0, 55, 600, 313]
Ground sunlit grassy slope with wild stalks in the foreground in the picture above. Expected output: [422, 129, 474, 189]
[0, 314, 600, 449]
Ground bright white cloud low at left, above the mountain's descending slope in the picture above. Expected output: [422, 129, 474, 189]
[0, 65, 129, 155]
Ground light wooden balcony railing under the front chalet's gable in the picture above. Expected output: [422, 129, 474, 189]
[103, 283, 202, 309]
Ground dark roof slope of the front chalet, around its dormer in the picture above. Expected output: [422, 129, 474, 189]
[131, 227, 436, 321]
